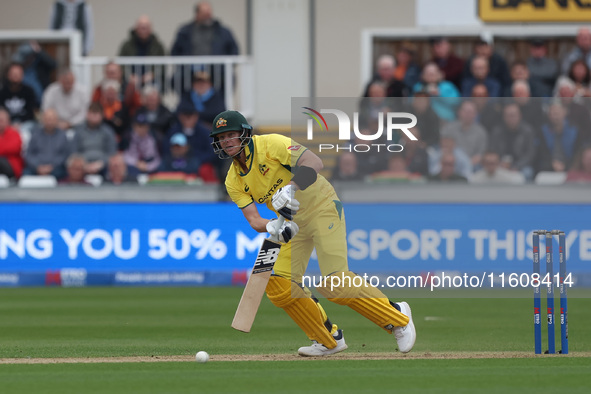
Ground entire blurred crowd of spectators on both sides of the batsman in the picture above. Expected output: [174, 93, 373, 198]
[0, 0, 591, 185]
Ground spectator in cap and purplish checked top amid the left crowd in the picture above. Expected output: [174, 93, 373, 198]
[123, 112, 160, 177]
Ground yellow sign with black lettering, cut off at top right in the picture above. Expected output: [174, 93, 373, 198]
[477, 0, 591, 22]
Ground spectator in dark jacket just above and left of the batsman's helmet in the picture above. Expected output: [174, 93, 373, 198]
[181, 71, 226, 125]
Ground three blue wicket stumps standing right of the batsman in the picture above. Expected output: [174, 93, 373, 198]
[532, 230, 568, 354]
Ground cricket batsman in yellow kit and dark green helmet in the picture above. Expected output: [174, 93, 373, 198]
[210, 111, 416, 356]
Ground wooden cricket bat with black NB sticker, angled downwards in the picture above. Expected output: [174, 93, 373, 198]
[232, 217, 285, 332]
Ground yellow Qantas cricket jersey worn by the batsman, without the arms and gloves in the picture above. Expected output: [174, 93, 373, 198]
[226, 134, 338, 224]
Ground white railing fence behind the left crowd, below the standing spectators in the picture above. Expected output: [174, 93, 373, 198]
[0, 30, 254, 118]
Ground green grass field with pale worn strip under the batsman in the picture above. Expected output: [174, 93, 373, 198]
[0, 288, 591, 393]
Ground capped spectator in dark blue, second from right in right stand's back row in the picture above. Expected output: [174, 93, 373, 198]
[526, 38, 559, 97]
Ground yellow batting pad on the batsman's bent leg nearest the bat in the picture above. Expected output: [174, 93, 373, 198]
[266, 275, 337, 349]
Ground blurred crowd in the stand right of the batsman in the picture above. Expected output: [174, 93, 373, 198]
[332, 27, 591, 184]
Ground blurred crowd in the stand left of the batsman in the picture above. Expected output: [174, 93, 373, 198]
[0, 0, 238, 185]
